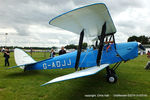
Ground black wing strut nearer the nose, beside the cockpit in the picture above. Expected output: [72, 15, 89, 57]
[97, 22, 106, 66]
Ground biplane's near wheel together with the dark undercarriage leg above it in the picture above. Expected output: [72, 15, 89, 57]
[106, 66, 118, 83]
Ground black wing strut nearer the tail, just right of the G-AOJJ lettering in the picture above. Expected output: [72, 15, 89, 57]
[75, 29, 84, 71]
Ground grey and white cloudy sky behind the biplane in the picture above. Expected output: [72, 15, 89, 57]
[0, 0, 150, 47]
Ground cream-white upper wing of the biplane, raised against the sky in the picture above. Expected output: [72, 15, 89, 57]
[49, 3, 116, 37]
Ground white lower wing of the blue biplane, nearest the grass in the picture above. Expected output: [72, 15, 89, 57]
[41, 64, 109, 86]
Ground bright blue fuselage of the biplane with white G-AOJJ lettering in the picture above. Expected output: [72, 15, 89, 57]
[26, 42, 138, 70]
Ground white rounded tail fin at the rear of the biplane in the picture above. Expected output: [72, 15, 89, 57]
[14, 48, 36, 69]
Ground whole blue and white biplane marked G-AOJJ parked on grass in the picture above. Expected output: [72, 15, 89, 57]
[8, 3, 144, 86]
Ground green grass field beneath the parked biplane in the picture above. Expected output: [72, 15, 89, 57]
[0, 53, 150, 100]
